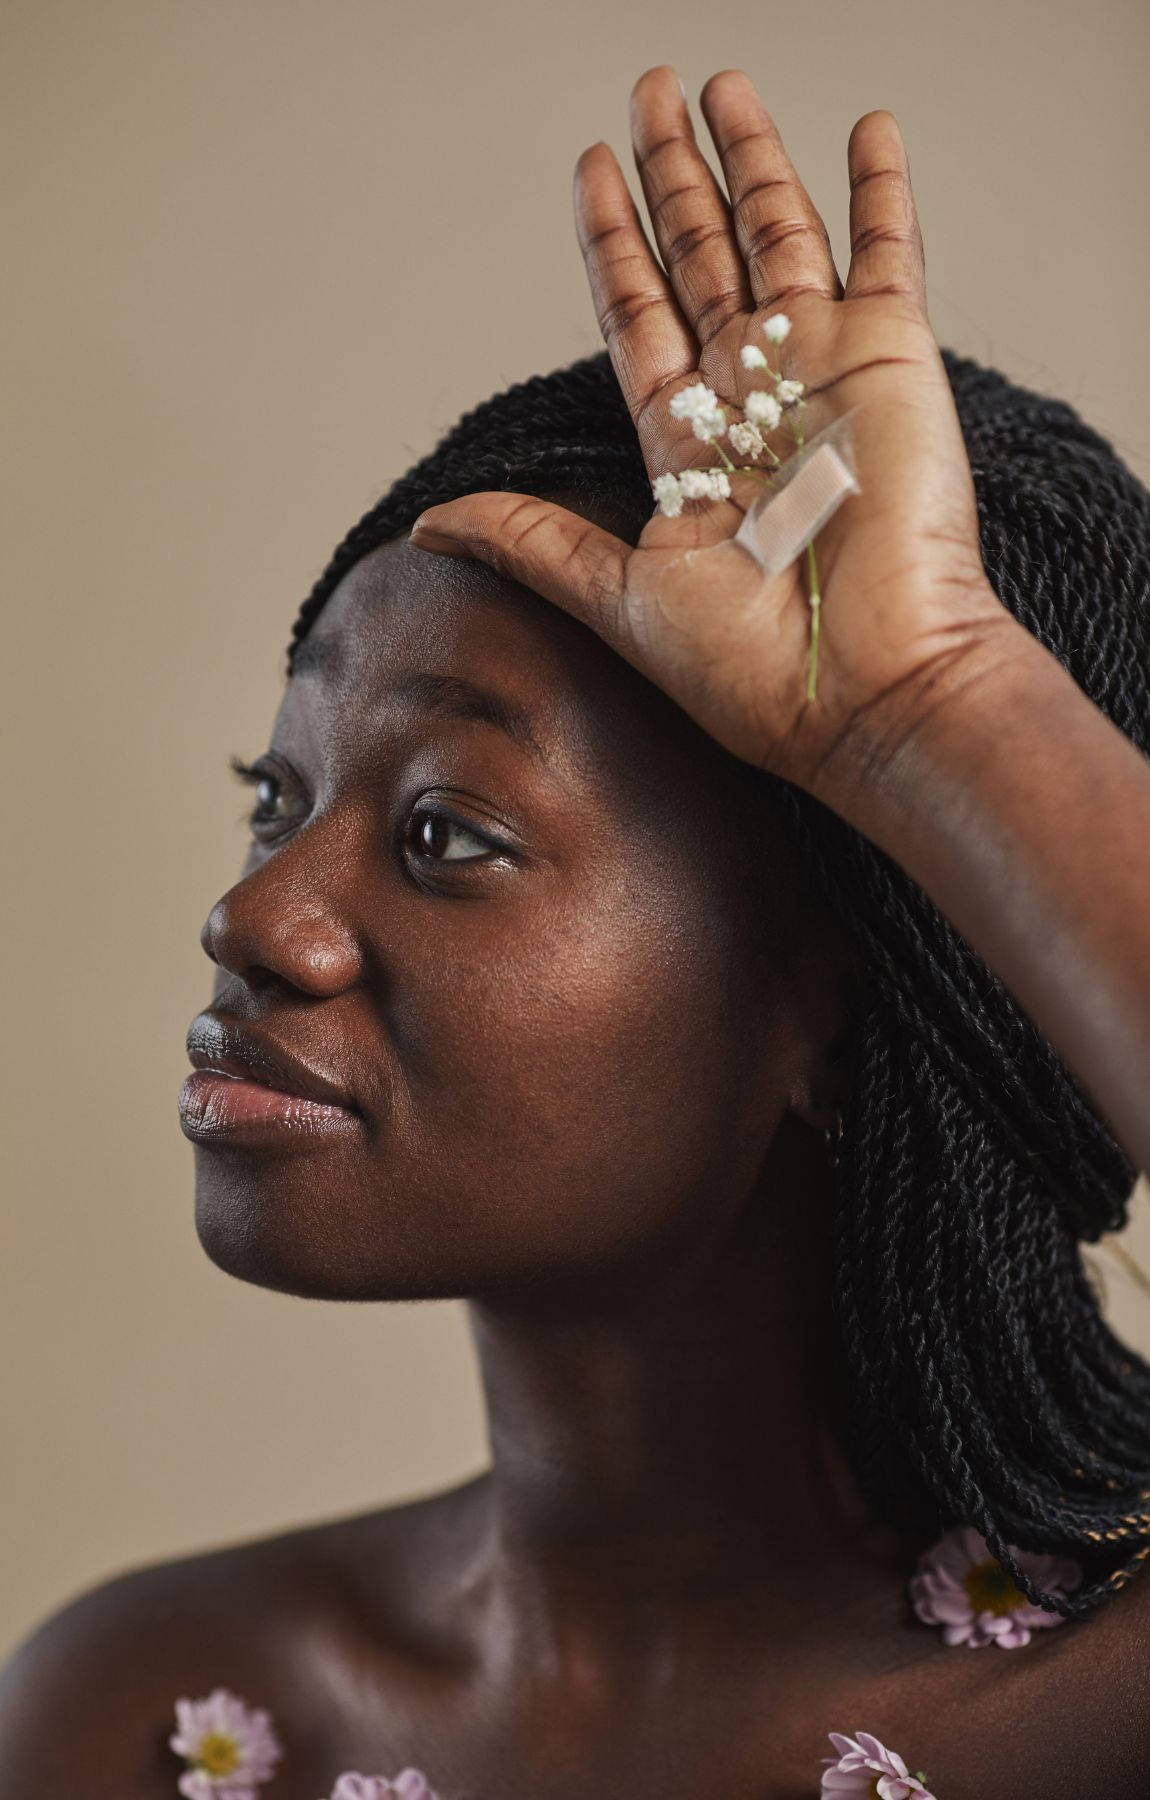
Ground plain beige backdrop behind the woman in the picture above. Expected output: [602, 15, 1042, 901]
[0, 0, 1150, 1651]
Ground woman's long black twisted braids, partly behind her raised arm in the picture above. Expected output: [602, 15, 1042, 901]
[288, 349, 1150, 1616]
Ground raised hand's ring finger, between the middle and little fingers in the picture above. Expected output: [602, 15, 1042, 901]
[700, 68, 842, 306]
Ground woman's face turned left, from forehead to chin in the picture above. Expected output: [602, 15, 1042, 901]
[182, 525, 845, 1300]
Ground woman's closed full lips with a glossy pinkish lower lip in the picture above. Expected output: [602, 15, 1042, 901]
[180, 1012, 364, 1147]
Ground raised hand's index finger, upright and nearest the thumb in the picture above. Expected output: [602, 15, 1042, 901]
[574, 144, 698, 473]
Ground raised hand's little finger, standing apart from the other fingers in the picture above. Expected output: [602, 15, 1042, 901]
[846, 110, 927, 311]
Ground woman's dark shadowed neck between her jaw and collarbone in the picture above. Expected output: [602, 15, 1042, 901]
[472, 1120, 898, 1656]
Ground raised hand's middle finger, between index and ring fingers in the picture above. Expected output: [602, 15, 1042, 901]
[632, 65, 754, 349]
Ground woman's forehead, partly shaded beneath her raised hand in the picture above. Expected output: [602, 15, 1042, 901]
[275, 538, 759, 838]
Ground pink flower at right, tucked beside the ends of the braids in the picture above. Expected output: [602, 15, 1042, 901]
[911, 1525, 1082, 1651]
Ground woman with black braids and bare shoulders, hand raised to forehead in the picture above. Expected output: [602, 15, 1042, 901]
[0, 68, 1150, 1800]
